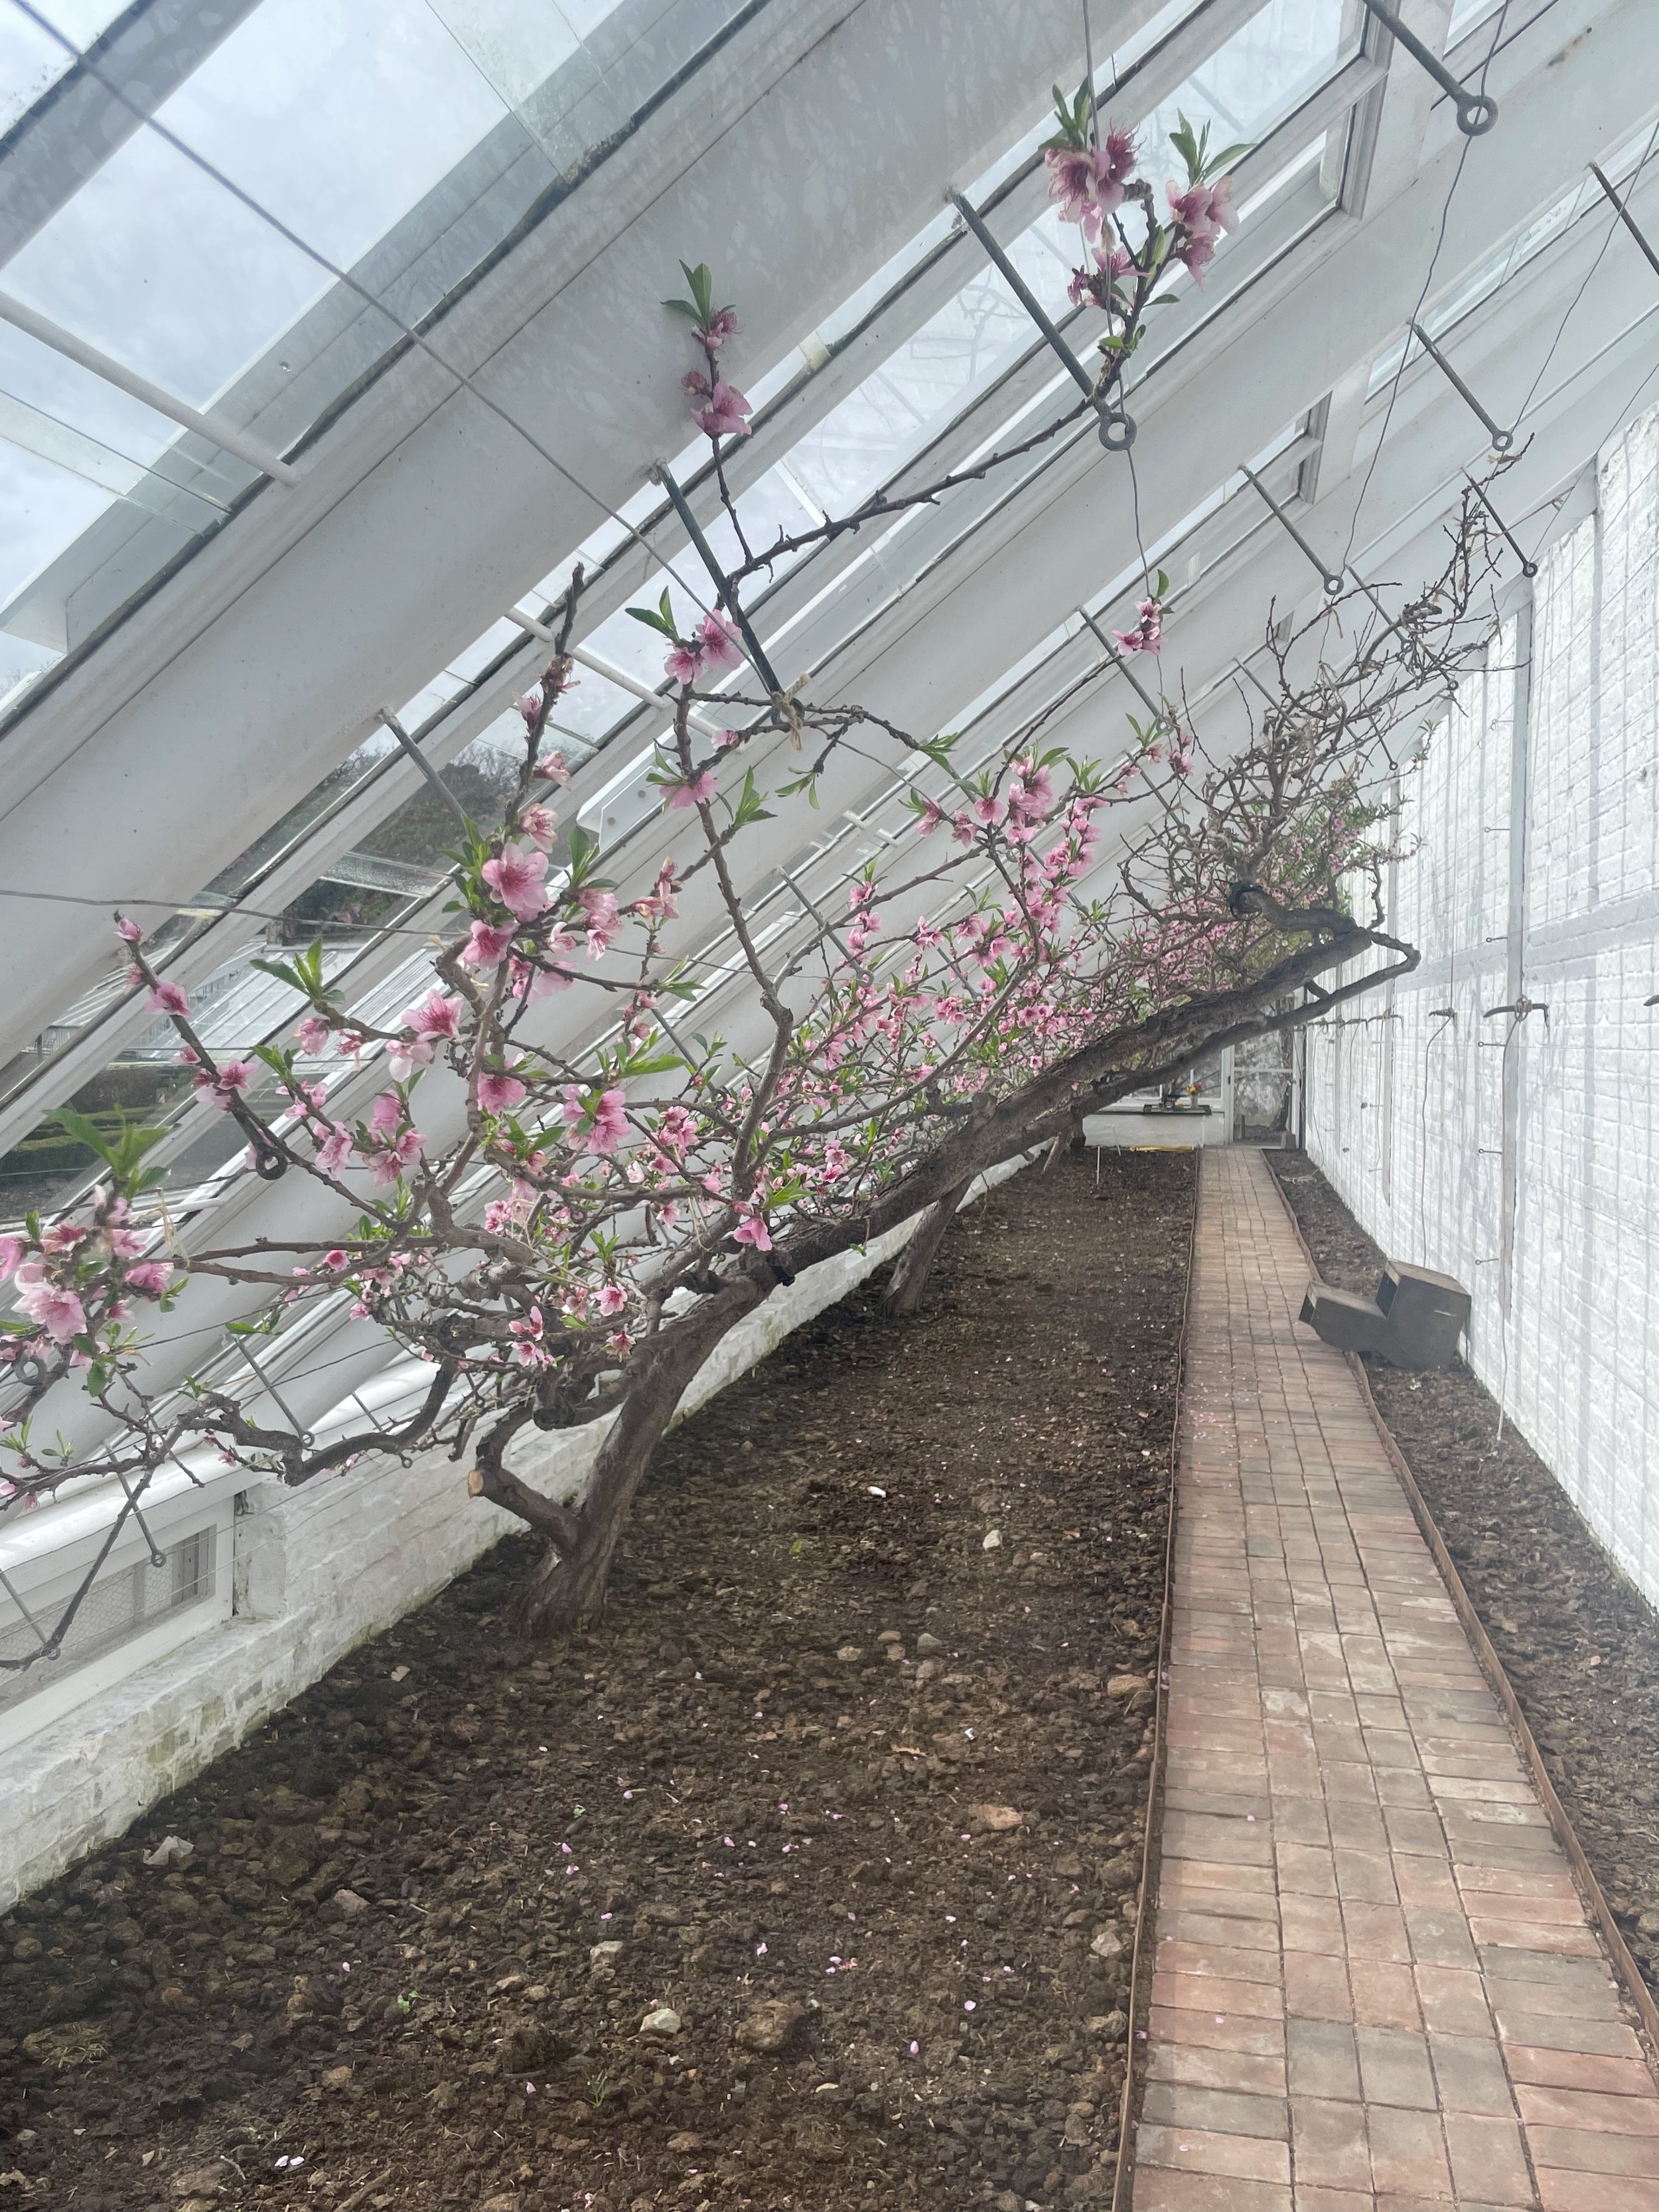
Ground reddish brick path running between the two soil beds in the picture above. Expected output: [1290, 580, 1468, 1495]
[1135, 1150, 1659, 2212]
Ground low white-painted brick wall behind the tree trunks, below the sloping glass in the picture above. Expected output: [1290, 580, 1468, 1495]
[0, 1157, 1027, 1911]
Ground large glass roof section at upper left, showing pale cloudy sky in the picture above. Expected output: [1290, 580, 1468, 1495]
[0, 0, 739, 705]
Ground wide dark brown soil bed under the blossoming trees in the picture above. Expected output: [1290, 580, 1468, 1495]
[0, 1155, 1192, 2212]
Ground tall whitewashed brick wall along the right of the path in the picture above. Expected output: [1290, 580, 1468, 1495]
[1305, 413, 1659, 1601]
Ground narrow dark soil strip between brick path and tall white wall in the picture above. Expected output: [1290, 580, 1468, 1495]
[1269, 1152, 1659, 1993]
